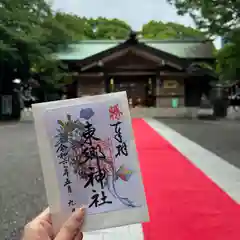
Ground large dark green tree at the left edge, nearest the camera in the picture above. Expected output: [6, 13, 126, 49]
[0, 0, 74, 116]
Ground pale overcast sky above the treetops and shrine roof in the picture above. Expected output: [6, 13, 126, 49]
[52, 0, 220, 47]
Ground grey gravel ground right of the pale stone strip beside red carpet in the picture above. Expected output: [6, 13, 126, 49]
[158, 119, 240, 168]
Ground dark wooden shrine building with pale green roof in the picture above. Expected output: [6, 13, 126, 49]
[56, 33, 217, 107]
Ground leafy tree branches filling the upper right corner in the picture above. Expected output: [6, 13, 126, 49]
[168, 0, 240, 80]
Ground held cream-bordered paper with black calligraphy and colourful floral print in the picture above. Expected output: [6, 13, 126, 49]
[33, 92, 148, 231]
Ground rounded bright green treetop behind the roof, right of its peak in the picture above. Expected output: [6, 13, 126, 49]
[142, 21, 205, 39]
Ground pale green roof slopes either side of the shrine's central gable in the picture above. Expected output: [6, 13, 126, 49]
[56, 39, 214, 60]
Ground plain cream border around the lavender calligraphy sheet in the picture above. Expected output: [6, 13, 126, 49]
[32, 91, 149, 233]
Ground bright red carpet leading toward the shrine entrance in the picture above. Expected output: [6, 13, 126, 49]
[133, 119, 240, 240]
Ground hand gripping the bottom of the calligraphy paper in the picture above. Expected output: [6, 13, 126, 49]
[22, 208, 84, 240]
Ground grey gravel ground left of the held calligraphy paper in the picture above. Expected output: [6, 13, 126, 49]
[0, 123, 47, 240]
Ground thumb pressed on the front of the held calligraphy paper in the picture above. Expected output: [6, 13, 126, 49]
[55, 208, 84, 240]
